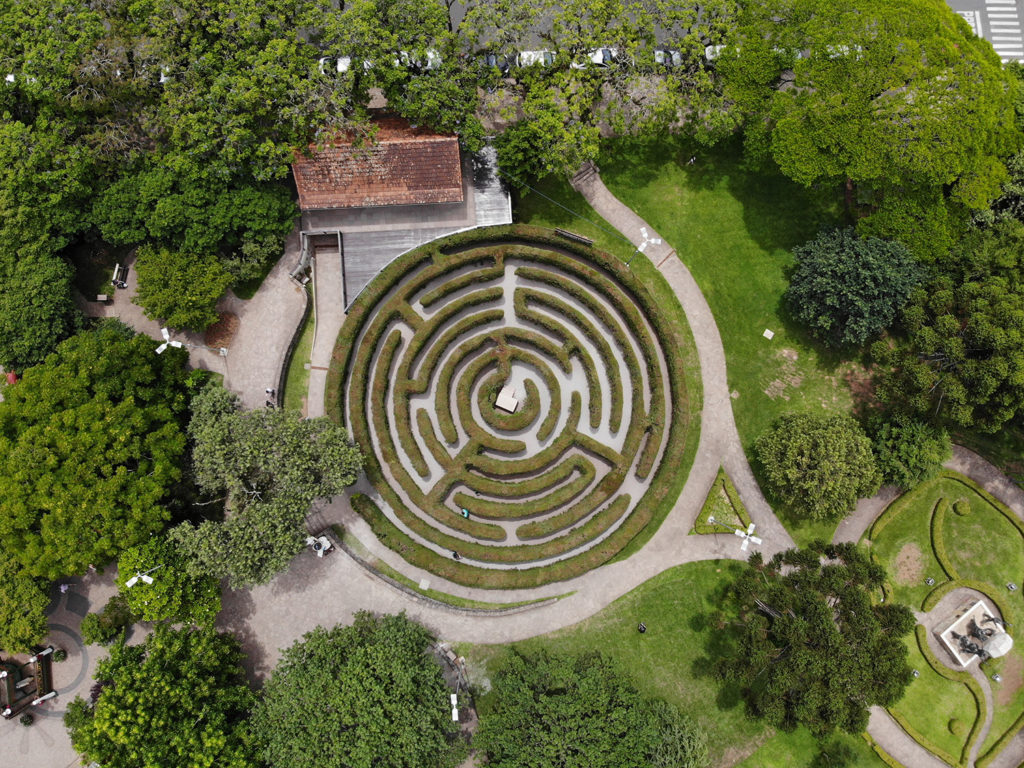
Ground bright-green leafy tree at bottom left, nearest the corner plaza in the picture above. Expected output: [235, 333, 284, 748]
[65, 625, 254, 768]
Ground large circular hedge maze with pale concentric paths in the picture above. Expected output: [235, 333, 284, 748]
[337, 231, 693, 587]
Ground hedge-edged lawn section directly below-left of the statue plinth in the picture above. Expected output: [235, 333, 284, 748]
[889, 628, 983, 765]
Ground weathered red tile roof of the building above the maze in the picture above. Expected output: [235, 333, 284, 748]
[292, 118, 463, 211]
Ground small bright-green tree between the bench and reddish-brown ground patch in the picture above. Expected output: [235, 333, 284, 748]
[133, 247, 232, 331]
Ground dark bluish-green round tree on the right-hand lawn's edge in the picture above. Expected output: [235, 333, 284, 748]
[784, 229, 922, 347]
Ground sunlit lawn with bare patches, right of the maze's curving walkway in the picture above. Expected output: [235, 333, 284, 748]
[601, 140, 855, 452]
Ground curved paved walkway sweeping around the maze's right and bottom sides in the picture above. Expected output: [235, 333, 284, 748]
[221, 165, 794, 663]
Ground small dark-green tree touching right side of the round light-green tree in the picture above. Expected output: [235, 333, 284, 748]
[871, 413, 952, 490]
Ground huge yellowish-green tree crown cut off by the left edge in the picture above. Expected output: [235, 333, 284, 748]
[0, 321, 187, 579]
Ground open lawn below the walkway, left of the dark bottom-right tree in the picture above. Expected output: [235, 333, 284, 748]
[459, 560, 882, 768]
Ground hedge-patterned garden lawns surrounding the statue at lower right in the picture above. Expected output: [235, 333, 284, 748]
[864, 472, 1024, 765]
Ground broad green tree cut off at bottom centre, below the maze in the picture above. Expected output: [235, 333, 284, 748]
[473, 650, 708, 768]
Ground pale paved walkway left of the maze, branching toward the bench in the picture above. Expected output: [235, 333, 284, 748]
[76, 229, 306, 409]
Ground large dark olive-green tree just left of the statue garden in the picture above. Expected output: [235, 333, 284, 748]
[722, 542, 914, 736]
